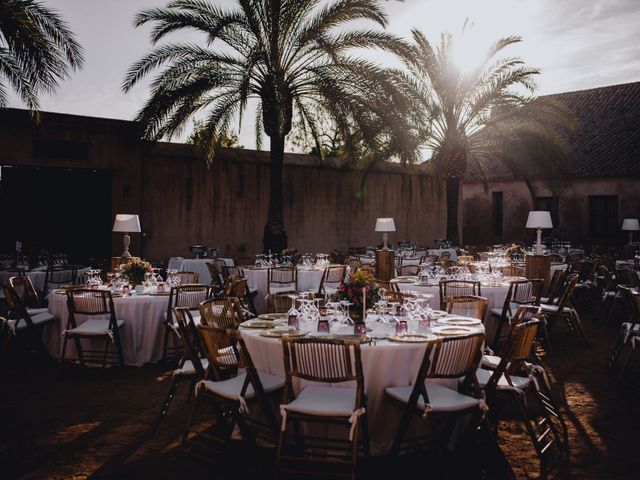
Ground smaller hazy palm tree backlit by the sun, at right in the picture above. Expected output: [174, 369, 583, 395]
[404, 30, 572, 244]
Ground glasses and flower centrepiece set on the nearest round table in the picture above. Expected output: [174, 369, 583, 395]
[286, 291, 433, 339]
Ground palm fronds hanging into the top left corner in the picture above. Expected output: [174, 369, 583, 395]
[0, 0, 83, 113]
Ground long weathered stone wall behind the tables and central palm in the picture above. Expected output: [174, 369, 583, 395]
[0, 109, 446, 260]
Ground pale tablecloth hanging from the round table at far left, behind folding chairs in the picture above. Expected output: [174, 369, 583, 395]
[43, 293, 169, 366]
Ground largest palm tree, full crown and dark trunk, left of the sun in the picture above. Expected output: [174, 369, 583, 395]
[123, 0, 416, 252]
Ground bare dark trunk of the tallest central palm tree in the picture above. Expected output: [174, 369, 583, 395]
[262, 135, 287, 253]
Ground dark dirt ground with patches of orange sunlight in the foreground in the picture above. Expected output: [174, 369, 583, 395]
[0, 304, 640, 479]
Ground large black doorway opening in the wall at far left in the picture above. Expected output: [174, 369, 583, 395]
[0, 166, 112, 264]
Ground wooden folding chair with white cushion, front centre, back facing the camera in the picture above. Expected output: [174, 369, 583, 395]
[276, 336, 369, 479]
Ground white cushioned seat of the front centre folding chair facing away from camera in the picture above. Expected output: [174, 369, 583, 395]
[283, 385, 357, 417]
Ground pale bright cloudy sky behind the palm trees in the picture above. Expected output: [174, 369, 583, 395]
[9, 0, 640, 148]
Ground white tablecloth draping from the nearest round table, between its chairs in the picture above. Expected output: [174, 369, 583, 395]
[240, 322, 483, 454]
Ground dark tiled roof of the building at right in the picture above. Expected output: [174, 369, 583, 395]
[466, 82, 640, 181]
